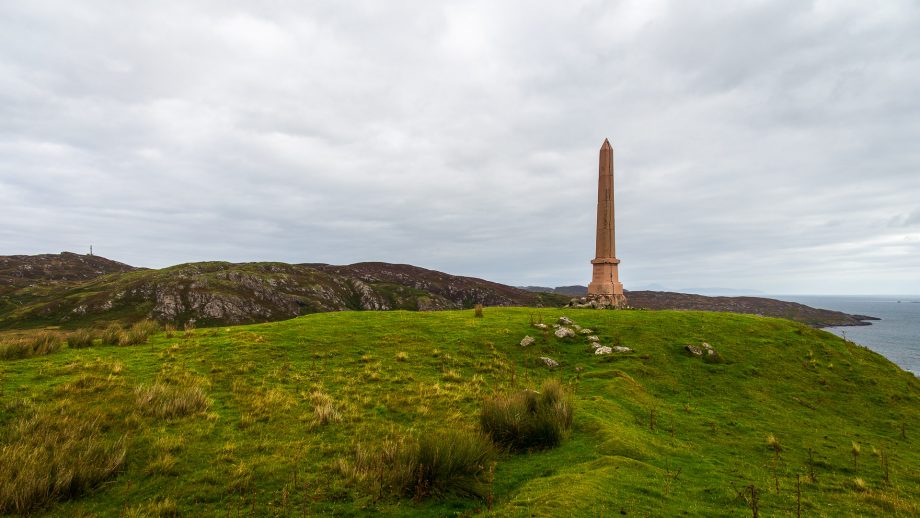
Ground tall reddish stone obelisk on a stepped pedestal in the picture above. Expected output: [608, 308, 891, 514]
[588, 139, 626, 307]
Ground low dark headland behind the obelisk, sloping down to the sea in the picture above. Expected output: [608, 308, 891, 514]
[524, 286, 878, 327]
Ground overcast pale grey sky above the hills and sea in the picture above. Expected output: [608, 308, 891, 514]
[0, 0, 920, 294]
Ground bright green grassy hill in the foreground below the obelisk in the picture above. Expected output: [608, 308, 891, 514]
[0, 308, 920, 516]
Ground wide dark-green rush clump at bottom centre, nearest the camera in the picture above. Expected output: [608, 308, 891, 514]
[339, 429, 496, 499]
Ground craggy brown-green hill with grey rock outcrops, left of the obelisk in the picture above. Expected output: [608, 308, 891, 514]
[0, 254, 568, 329]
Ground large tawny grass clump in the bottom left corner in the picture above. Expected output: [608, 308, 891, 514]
[0, 413, 126, 514]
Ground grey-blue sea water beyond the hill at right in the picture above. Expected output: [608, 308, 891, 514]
[768, 295, 920, 375]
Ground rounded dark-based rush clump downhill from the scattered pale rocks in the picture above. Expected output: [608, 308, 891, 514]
[479, 380, 573, 451]
